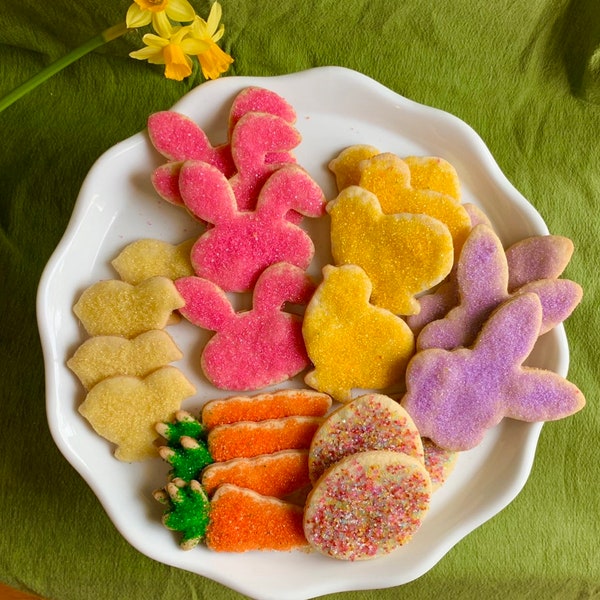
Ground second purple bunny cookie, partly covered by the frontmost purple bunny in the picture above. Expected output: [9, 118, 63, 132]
[417, 225, 582, 350]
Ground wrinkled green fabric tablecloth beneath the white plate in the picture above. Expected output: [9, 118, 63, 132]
[0, 0, 600, 600]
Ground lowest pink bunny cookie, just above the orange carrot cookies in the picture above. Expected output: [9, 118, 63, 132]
[175, 263, 314, 391]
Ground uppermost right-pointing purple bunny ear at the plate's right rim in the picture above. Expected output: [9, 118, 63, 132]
[506, 235, 574, 292]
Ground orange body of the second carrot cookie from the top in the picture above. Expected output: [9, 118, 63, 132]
[208, 417, 323, 461]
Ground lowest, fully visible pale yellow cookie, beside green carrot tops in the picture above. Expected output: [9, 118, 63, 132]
[79, 366, 196, 462]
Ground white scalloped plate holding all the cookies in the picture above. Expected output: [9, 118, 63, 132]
[38, 67, 569, 600]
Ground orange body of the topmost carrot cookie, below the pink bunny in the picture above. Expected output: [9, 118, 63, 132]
[202, 390, 331, 429]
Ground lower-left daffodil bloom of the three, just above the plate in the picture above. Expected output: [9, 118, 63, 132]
[129, 19, 208, 81]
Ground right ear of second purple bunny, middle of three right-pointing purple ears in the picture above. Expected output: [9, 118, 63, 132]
[516, 279, 583, 335]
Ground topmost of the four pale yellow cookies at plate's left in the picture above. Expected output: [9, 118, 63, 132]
[111, 238, 196, 285]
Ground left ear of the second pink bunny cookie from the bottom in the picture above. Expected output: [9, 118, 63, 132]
[179, 161, 237, 223]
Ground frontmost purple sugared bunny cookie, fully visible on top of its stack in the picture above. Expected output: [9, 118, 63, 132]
[402, 293, 585, 451]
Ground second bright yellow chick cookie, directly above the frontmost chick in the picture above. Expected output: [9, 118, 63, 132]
[327, 186, 454, 315]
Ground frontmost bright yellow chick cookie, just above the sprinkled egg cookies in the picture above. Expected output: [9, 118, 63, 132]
[302, 265, 414, 402]
